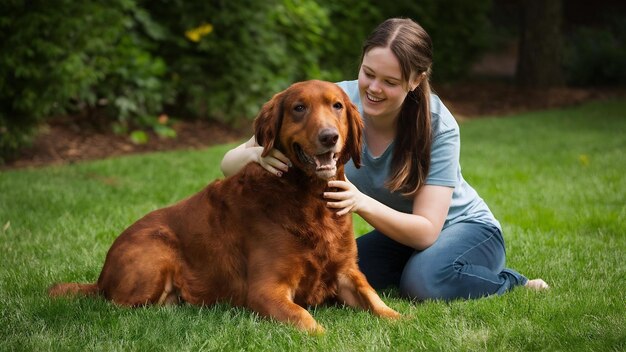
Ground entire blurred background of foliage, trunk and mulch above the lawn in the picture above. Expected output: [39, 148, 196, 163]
[0, 0, 626, 168]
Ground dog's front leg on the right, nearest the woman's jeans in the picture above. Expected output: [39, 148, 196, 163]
[337, 268, 400, 318]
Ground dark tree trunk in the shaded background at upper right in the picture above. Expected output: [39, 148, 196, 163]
[517, 0, 564, 88]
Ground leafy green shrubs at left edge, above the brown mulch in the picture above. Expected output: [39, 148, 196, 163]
[0, 0, 170, 162]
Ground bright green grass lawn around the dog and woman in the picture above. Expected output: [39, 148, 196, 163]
[0, 101, 626, 351]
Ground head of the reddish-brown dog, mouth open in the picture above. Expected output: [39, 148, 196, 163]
[254, 80, 363, 180]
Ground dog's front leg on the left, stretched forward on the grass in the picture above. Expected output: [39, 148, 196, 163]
[247, 282, 324, 334]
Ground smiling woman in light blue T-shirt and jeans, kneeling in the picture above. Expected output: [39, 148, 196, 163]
[222, 18, 548, 300]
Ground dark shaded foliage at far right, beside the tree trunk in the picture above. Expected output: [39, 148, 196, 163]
[564, 17, 626, 86]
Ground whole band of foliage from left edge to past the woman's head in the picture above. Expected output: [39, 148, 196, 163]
[0, 0, 490, 162]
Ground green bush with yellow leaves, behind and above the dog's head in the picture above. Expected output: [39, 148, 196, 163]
[140, 0, 330, 122]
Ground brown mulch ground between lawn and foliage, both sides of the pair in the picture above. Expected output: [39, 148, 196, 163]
[0, 81, 626, 170]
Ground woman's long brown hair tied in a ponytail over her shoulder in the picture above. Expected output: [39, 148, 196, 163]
[361, 18, 433, 196]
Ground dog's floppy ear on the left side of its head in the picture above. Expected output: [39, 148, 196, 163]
[254, 92, 284, 156]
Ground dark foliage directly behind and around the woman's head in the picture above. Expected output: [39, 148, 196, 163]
[316, 0, 492, 81]
